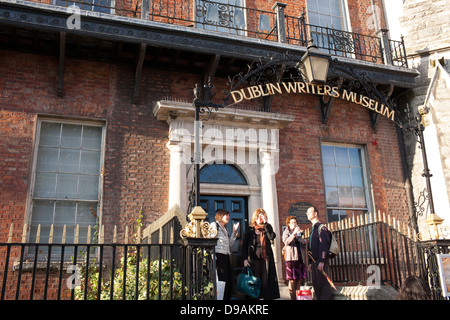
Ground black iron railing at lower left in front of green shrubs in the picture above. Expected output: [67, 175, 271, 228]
[0, 231, 216, 300]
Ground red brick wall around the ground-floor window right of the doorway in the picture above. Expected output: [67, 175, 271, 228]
[272, 94, 408, 225]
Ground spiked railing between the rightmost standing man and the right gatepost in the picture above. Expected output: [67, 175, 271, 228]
[330, 221, 423, 289]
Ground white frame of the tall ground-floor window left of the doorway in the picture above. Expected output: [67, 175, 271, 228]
[26, 116, 106, 243]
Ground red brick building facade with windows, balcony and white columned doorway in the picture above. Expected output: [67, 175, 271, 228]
[0, 0, 417, 296]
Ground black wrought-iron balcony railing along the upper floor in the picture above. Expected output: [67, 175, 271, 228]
[9, 0, 408, 67]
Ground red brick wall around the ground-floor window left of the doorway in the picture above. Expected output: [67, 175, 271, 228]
[0, 51, 178, 241]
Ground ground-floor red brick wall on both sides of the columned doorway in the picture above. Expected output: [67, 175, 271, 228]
[0, 46, 407, 239]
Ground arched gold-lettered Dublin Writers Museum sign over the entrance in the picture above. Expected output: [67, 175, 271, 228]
[230, 81, 395, 121]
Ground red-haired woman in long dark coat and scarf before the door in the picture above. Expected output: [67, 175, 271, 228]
[242, 209, 280, 300]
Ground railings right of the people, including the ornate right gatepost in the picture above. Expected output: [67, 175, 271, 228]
[306, 212, 450, 300]
